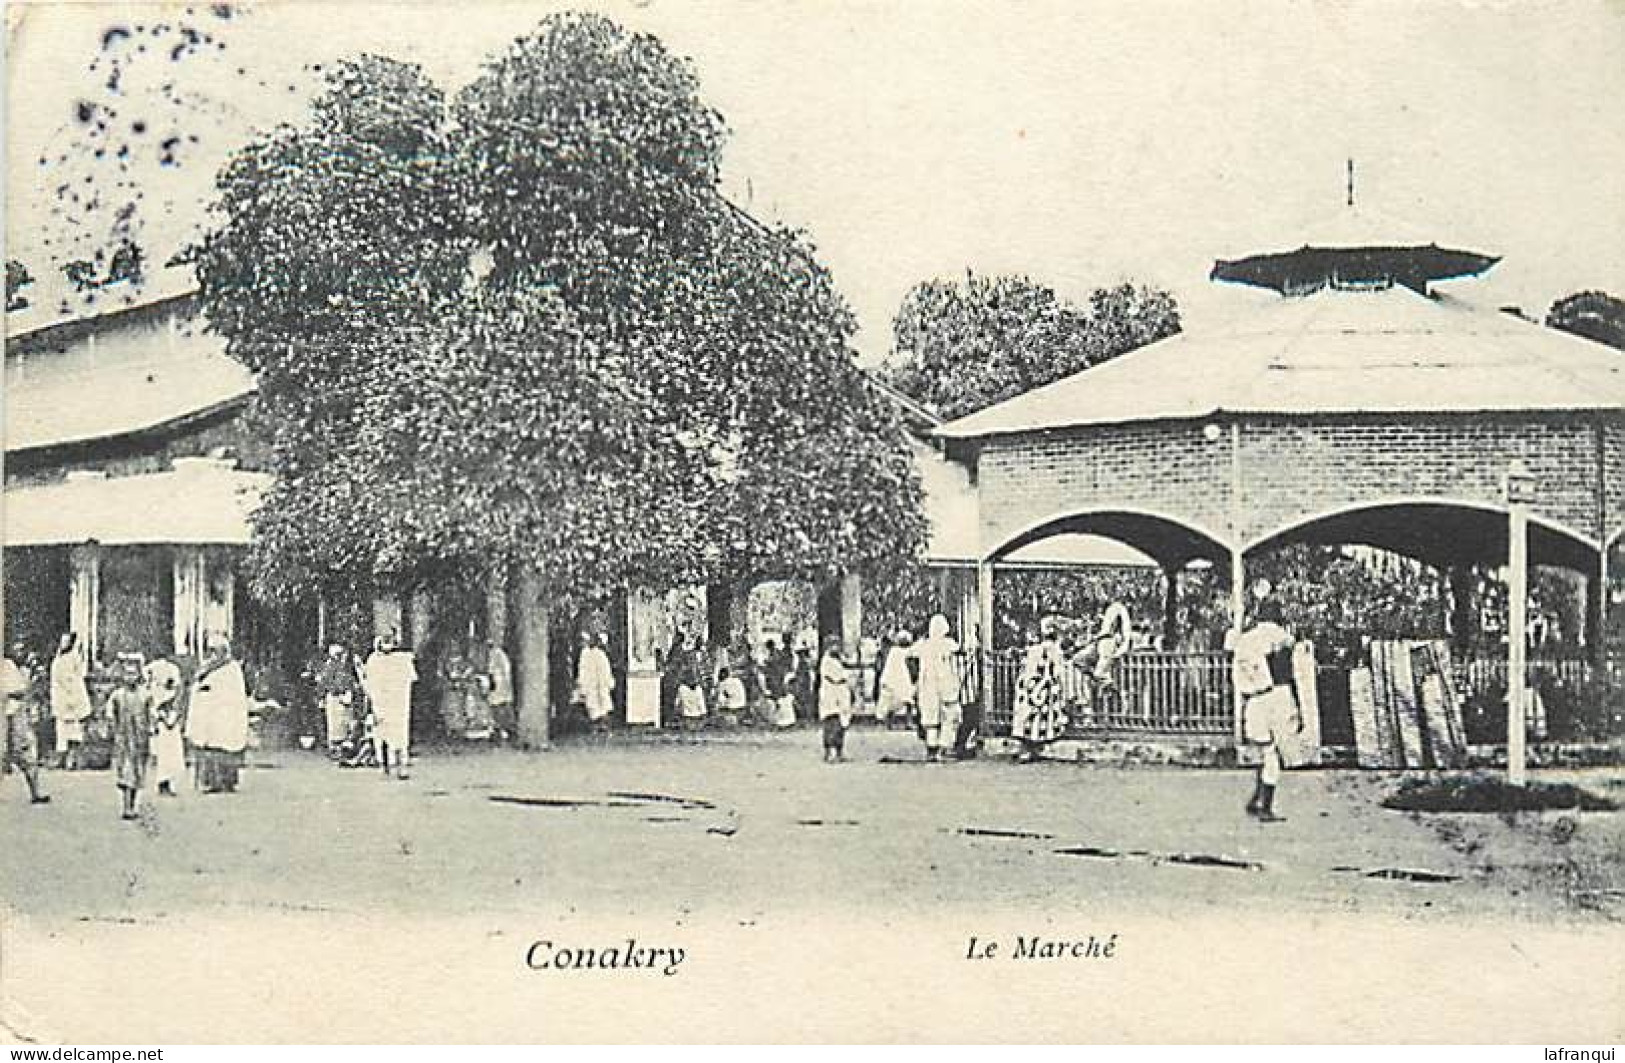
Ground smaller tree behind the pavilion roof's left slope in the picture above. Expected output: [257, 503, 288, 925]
[884, 273, 1180, 418]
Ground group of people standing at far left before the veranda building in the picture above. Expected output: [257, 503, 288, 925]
[0, 632, 249, 819]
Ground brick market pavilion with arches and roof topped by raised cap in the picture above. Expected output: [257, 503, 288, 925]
[936, 205, 1625, 744]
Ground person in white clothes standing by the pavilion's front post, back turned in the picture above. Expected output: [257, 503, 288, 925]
[1232, 600, 1302, 822]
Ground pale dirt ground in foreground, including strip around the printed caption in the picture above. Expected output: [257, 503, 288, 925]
[0, 730, 1625, 1043]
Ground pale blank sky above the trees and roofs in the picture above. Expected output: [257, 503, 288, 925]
[5, 0, 1625, 361]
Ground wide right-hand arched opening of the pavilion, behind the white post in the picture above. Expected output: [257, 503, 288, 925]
[1245, 499, 1606, 744]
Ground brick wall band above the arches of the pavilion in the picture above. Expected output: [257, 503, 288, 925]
[977, 414, 1625, 565]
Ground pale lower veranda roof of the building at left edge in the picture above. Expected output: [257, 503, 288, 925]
[0, 458, 271, 546]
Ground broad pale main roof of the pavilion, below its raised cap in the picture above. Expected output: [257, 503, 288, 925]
[936, 286, 1625, 439]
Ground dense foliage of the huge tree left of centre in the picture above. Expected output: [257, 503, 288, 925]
[197, 15, 923, 600]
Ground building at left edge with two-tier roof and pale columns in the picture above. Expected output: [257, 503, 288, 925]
[3, 270, 284, 679]
